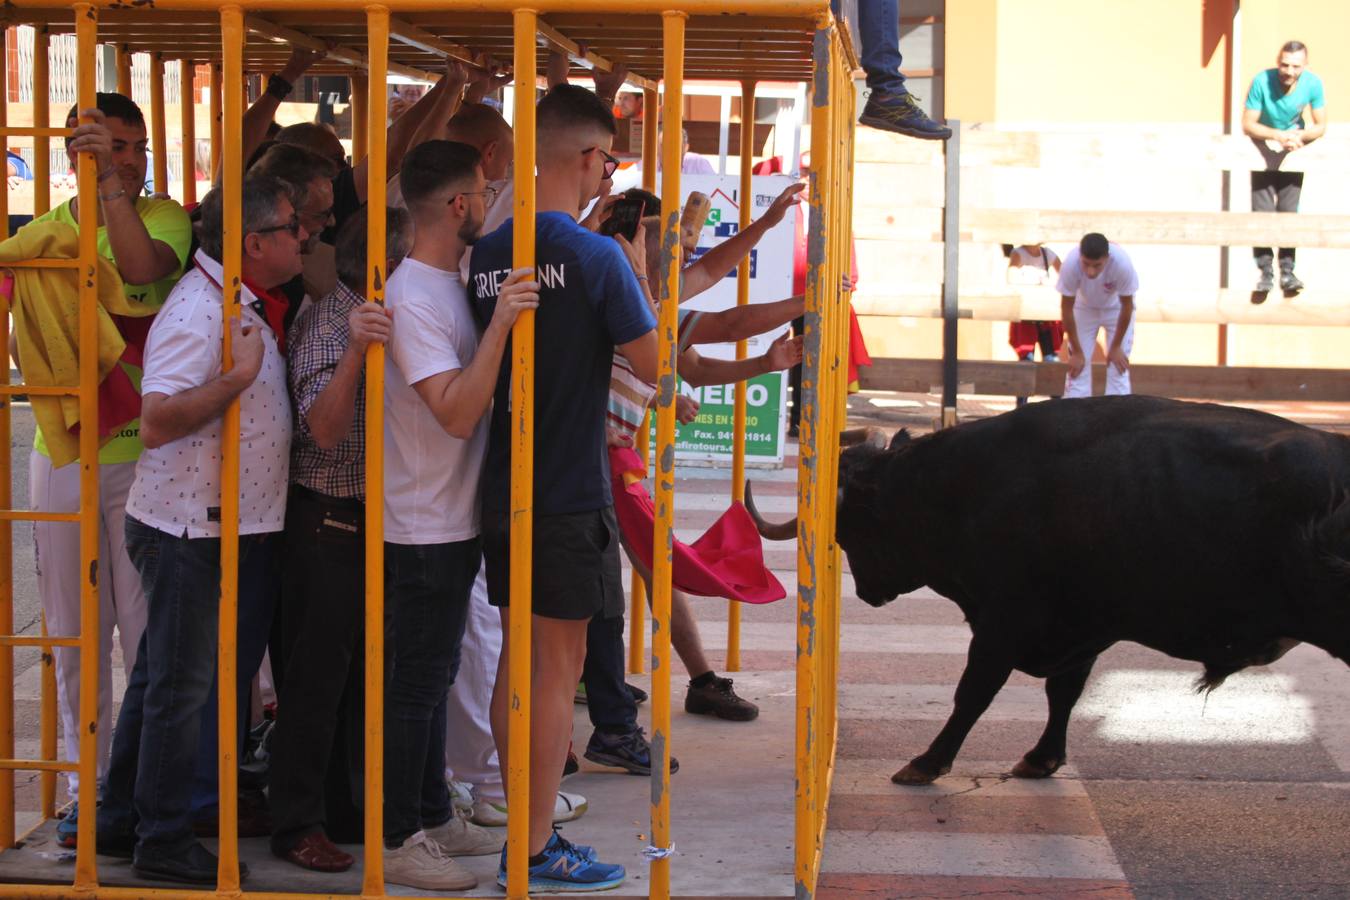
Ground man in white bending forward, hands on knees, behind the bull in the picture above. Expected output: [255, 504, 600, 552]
[1057, 232, 1139, 397]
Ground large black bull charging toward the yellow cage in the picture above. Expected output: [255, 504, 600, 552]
[751, 397, 1350, 784]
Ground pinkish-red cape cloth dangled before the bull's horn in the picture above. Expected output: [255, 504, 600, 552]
[609, 447, 787, 603]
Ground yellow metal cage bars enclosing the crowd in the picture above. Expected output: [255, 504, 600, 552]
[0, 0, 853, 899]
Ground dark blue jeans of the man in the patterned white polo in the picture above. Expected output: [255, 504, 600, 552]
[99, 515, 266, 853]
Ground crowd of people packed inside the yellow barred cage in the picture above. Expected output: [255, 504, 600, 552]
[12, 51, 837, 891]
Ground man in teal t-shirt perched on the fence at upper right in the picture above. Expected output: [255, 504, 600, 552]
[1242, 40, 1327, 294]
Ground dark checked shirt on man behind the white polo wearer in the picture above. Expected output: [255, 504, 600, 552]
[286, 282, 366, 499]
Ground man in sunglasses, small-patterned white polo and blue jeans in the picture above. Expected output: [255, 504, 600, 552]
[99, 177, 308, 884]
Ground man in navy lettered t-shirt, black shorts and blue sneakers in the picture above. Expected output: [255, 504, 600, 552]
[468, 85, 657, 891]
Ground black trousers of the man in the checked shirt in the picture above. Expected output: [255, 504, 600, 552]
[267, 484, 366, 853]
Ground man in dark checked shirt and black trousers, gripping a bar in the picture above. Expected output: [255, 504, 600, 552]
[270, 206, 412, 872]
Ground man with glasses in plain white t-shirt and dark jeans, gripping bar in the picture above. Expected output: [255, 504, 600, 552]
[385, 140, 539, 891]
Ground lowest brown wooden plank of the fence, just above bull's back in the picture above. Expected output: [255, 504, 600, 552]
[859, 358, 1350, 402]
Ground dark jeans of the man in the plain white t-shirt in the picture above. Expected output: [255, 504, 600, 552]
[385, 537, 483, 847]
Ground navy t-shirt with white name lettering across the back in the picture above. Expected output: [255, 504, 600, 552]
[468, 212, 656, 517]
